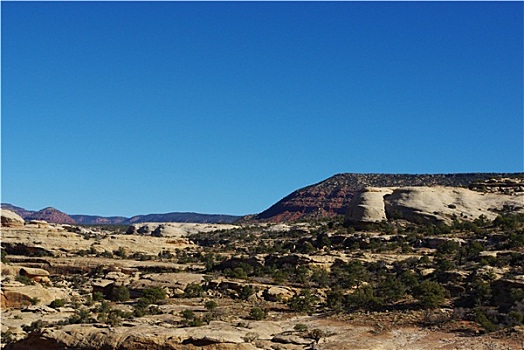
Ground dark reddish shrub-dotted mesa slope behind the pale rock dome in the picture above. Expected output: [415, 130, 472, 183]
[252, 173, 524, 222]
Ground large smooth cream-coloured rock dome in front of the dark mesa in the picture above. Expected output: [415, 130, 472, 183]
[346, 186, 524, 224]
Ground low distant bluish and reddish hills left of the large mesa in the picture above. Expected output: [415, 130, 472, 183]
[2, 203, 240, 225]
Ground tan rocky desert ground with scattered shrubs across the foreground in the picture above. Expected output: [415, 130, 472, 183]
[1, 205, 524, 350]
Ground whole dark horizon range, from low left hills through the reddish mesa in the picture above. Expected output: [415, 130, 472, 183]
[2, 173, 524, 225]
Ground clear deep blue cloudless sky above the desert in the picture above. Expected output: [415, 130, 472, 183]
[1, 1, 523, 216]
